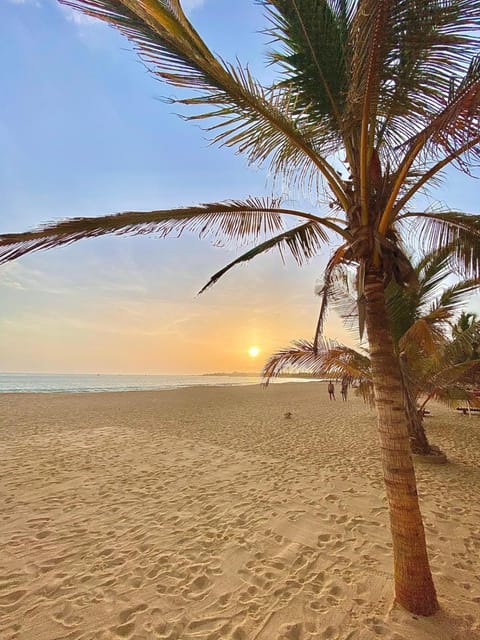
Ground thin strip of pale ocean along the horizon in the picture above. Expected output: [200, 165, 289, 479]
[0, 373, 316, 393]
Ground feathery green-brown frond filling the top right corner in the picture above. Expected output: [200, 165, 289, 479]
[378, 0, 480, 148]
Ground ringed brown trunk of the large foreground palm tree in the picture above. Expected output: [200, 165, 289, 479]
[365, 271, 438, 616]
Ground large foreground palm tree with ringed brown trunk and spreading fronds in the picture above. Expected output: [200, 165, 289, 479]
[0, 0, 480, 615]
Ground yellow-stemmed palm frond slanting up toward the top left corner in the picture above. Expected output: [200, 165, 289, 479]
[59, 0, 348, 207]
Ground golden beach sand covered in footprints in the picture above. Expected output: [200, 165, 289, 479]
[0, 382, 480, 640]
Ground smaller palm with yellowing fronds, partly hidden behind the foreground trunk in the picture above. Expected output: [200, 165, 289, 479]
[264, 246, 480, 458]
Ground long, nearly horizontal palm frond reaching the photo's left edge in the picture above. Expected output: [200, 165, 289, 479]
[0, 198, 326, 264]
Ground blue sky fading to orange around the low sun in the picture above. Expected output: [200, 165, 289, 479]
[0, 0, 478, 374]
